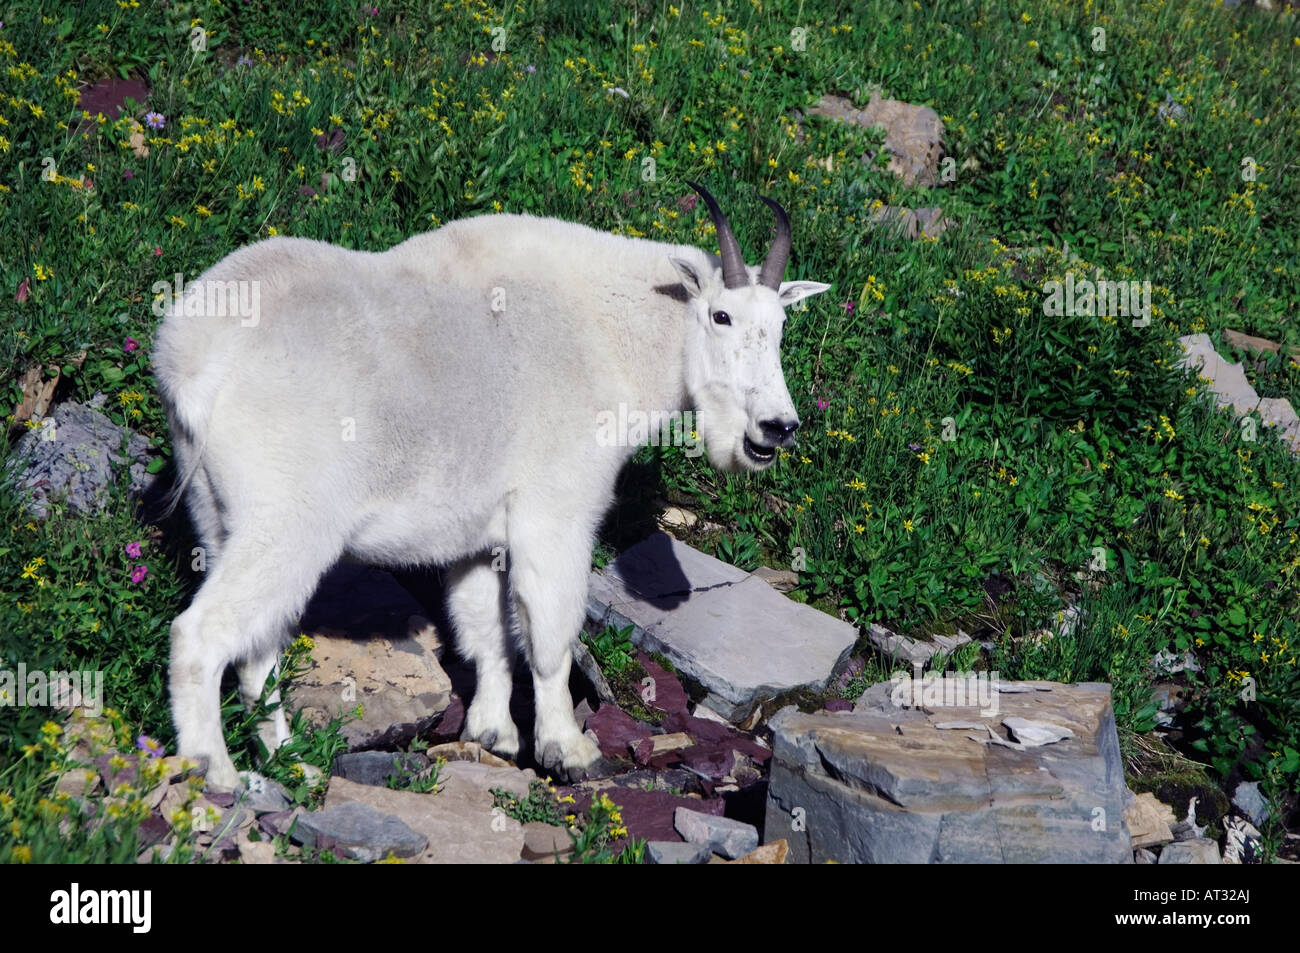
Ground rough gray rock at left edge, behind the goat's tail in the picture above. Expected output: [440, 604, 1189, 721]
[5, 403, 150, 520]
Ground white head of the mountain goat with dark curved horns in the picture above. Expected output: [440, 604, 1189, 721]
[672, 182, 831, 471]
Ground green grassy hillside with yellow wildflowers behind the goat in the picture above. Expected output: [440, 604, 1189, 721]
[0, 0, 1300, 863]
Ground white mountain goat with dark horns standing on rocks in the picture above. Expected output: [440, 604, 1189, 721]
[153, 183, 829, 788]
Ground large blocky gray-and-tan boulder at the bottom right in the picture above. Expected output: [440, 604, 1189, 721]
[764, 683, 1132, 863]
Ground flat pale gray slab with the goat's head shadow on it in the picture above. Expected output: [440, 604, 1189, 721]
[588, 533, 858, 722]
